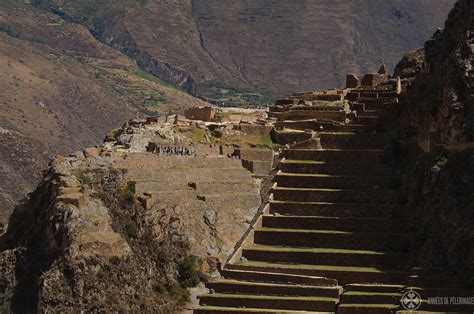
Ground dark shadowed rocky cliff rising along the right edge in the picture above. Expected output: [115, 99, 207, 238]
[397, 0, 474, 286]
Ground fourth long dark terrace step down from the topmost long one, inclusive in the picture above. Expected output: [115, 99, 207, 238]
[272, 187, 402, 204]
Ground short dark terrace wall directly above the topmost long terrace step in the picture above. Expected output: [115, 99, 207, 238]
[320, 133, 390, 150]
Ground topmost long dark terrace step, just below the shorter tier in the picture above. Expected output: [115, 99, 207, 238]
[283, 149, 390, 163]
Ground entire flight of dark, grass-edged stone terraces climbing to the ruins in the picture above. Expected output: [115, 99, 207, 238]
[194, 91, 474, 314]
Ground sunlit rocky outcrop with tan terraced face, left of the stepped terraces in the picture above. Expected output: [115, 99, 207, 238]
[0, 120, 261, 313]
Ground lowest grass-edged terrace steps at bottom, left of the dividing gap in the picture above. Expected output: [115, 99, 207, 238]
[194, 269, 341, 313]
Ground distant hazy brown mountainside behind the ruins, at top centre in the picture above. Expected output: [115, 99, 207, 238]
[36, 0, 454, 101]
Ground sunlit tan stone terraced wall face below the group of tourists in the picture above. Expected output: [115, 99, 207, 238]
[116, 154, 261, 257]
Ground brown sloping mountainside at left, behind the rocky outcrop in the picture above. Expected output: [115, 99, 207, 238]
[0, 1, 207, 224]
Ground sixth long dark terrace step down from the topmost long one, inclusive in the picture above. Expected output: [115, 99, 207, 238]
[262, 215, 407, 233]
